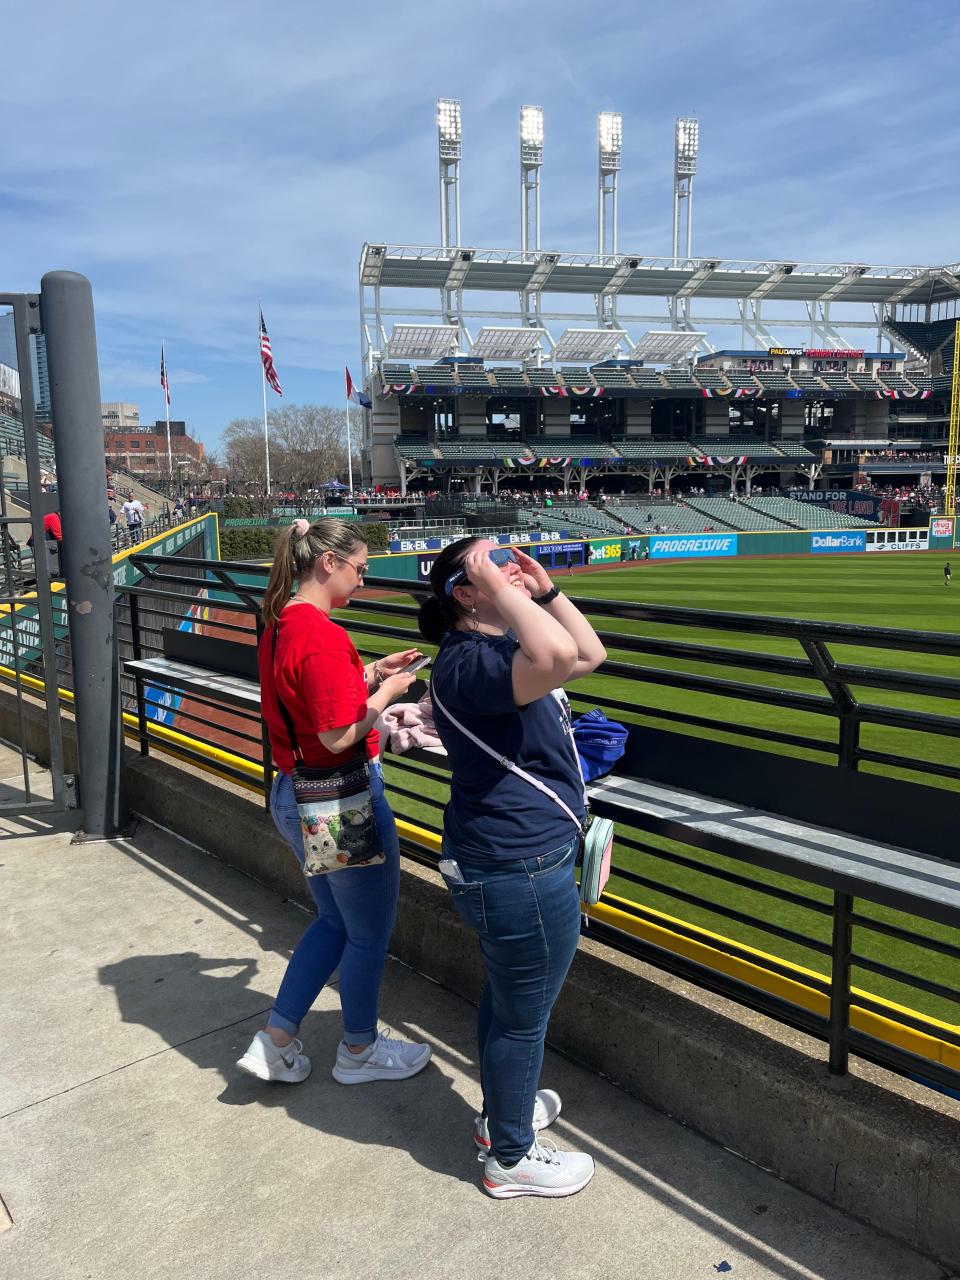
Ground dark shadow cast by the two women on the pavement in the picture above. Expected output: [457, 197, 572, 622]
[99, 951, 476, 1181]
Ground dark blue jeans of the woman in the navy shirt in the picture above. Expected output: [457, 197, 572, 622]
[443, 838, 580, 1165]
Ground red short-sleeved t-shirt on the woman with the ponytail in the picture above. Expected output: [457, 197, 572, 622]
[257, 604, 380, 773]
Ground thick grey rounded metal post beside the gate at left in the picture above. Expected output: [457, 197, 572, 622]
[40, 271, 127, 838]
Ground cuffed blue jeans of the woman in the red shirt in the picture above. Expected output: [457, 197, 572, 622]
[266, 760, 399, 1044]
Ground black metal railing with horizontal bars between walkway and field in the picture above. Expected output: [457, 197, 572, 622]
[103, 554, 960, 1091]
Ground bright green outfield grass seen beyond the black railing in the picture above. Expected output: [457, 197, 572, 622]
[343, 553, 960, 1023]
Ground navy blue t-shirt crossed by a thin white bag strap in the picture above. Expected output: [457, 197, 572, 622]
[430, 631, 584, 859]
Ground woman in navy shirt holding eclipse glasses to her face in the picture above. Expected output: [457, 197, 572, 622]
[420, 538, 605, 1198]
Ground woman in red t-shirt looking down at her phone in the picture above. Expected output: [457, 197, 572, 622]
[237, 520, 430, 1084]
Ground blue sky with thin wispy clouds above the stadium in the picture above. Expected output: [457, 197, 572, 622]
[0, 0, 960, 444]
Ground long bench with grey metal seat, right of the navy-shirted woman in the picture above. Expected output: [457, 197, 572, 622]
[398, 726, 960, 1092]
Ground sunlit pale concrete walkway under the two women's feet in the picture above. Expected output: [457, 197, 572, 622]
[0, 760, 943, 1280]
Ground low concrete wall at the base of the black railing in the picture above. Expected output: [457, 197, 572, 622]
[9, 691, 960, 1266]
